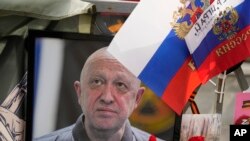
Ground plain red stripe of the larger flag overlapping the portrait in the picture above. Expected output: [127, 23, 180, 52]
[162, 56, 201, 115]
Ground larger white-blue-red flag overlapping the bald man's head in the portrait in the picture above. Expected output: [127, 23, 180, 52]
[108, 0, 201, 114]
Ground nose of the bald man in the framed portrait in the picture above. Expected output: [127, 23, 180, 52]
[101, 85, 114, 104]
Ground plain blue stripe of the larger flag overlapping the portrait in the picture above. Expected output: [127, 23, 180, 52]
[139, 30, 190, 96]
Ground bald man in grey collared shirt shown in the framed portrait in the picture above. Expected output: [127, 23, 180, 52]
[35, 47, 164, 141]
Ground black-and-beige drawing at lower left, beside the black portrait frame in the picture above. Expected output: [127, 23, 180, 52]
[0, 74, 27, 141]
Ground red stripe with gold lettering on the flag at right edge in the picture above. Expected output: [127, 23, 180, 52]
[198, 26, 250, 83]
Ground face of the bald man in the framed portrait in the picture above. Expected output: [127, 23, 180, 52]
[75, 59, 141, 129]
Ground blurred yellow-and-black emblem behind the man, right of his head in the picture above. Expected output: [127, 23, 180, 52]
[130, 83, 175, 140]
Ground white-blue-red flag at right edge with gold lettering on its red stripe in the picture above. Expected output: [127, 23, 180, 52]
[185, 0, 250, 83]
